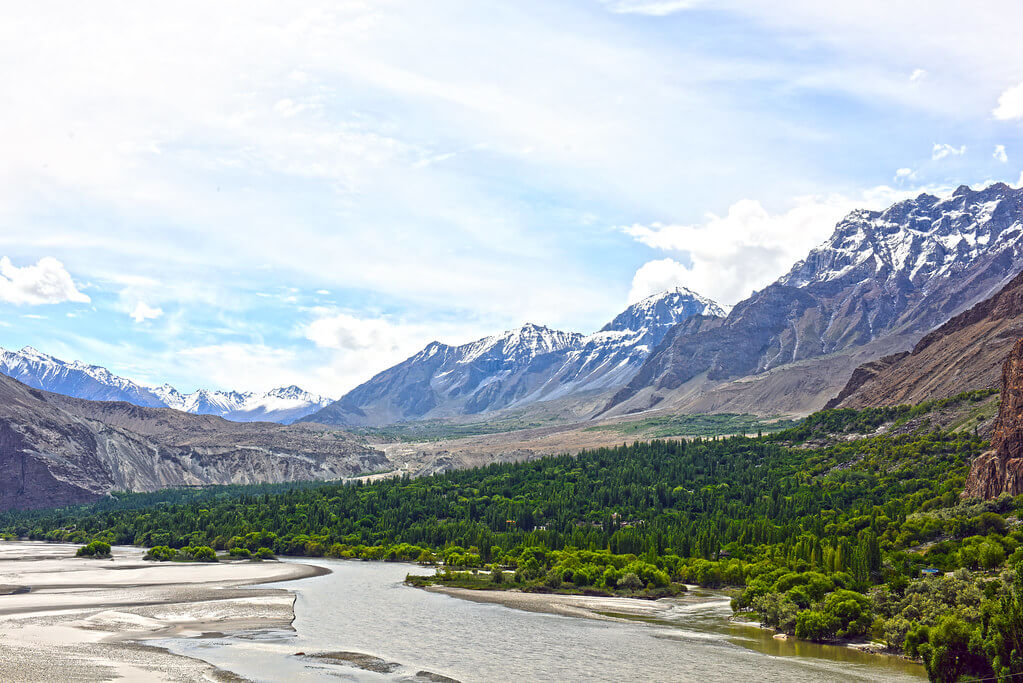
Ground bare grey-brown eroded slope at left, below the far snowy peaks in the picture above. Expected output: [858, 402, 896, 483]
[0, 375, 388, 510]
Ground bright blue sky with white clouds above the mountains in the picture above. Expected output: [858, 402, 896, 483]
[0, 0, 1023, 398]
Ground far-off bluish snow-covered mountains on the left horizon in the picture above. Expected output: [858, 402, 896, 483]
[0, 347, 331, 423]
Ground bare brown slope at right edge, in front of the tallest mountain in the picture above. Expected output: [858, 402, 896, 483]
[828, 265, 1023, 408]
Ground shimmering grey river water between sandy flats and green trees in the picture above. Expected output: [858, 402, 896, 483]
[159, 559, 923, 683]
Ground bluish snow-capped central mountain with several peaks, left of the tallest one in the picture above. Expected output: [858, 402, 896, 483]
[303, 288, 724, 425]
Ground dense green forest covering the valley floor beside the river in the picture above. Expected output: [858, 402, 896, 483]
[0, 393, 1023, 681]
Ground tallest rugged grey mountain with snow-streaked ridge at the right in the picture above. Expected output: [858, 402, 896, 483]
[602, 183, 1023, 414]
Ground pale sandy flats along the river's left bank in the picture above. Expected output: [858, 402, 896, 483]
[0, 542, 328, 681]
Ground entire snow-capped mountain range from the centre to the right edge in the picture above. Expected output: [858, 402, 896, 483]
[303, 183, 1023, 425]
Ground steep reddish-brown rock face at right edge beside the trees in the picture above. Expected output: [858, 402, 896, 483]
[963, 338, 1023, 498]
